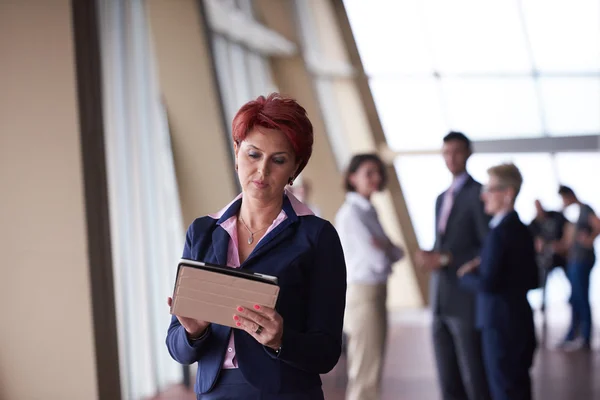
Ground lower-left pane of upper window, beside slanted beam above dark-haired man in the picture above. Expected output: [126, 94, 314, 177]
[370, 79, 448, 150]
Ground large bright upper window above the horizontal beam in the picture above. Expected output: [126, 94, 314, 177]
[344, 0, 600, 144]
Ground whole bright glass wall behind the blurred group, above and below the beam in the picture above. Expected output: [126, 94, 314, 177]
[344, 0, 600, 308]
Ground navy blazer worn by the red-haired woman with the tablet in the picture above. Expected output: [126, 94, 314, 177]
[167, 196, 346, 393]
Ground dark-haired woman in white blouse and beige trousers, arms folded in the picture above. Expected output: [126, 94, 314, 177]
[335, 154, 403, 400]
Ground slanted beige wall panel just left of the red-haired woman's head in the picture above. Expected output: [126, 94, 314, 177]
[146, 0, 237, 226]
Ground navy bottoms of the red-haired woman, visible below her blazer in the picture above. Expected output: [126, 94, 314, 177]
[196, 368, 324, 400]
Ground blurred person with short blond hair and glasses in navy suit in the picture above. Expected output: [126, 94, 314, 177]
[457, 164, 539, 400]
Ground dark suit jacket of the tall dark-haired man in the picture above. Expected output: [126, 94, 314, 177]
[430, 176, 490, 324]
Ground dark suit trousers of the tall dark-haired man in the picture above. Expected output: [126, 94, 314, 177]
[433, 316, 490, 400]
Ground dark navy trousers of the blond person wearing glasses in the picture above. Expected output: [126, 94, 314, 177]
[481, 328, 536, 400]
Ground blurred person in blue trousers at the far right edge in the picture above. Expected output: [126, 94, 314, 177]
[558, 186, 600, 350]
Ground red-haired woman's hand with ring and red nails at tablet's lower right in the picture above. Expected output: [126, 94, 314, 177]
[233, 304, 283, 350]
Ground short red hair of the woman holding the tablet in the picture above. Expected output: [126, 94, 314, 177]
[231, 93, 313, 175]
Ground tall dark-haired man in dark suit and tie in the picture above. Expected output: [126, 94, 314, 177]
[415, 132, 490, 400]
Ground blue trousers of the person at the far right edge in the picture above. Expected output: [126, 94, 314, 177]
[566, 262, 594, 343]
